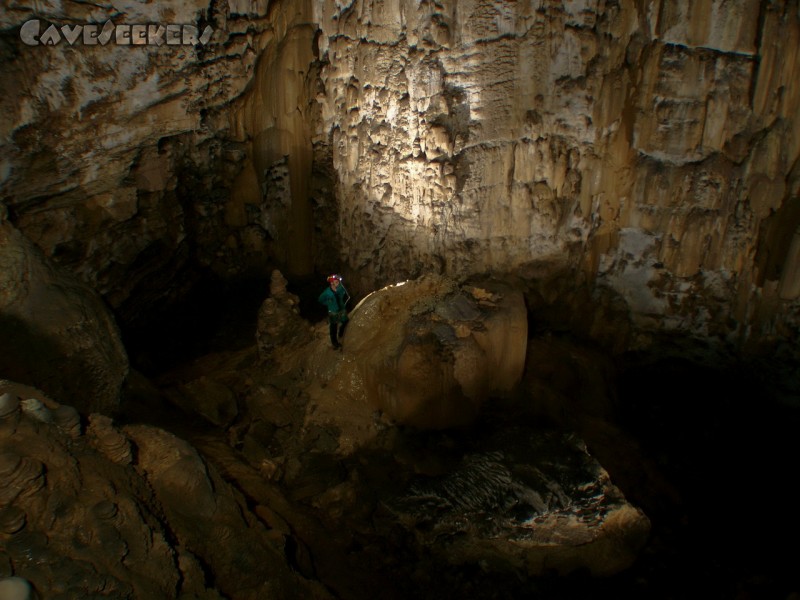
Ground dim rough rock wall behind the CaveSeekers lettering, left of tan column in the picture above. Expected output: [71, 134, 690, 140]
[0, 0, 300, 320]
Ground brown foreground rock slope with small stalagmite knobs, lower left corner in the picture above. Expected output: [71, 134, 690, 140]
[0, 380, 328, 600]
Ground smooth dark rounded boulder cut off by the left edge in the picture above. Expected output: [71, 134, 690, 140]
[0, 221, 128, 413]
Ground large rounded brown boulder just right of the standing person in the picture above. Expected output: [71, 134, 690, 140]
[345, 276, 528, 429]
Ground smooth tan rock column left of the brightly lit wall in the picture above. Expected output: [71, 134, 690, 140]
[231, 0, 316, 276]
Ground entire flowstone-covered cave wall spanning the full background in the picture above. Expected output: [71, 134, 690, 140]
[0, 0, 800, 356]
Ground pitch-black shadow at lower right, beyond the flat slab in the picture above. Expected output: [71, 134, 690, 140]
[605, 355, 800, 599]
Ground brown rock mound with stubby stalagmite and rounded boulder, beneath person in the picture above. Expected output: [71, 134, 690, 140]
[164, 271, 527, 462]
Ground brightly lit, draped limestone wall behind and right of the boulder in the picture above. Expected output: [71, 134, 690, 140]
[317, 0, 800, 352]
